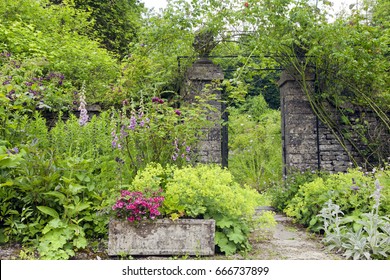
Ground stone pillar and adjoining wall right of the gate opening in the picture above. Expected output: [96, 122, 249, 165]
[279, 72, 390, 175]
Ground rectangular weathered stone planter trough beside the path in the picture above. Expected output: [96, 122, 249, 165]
[108, 219, 215, 256]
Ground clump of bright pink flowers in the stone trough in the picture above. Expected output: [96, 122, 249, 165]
[112, 190, 164, 222]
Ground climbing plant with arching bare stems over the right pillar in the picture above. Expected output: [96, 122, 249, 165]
[225, 0, 390, 164]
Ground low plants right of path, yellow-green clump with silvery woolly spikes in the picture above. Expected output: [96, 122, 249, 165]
[272, 167, 390, 259]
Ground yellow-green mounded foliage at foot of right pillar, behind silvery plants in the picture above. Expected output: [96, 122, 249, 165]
[284, 167, 390, 231]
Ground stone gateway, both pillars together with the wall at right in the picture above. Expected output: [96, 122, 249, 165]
[184, 57, 390, 175]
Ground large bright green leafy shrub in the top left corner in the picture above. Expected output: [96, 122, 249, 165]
[0, 0, 118, 109]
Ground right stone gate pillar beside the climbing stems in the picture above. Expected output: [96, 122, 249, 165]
[279, 72, 320, 175]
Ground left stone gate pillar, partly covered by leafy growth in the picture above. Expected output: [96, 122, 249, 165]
[182, 59, 227, 164]
